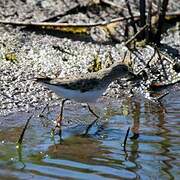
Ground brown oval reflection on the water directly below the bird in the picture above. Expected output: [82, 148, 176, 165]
[47, 136, 110, 164]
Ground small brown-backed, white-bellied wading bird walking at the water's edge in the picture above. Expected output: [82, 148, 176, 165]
[36, 62, 132, 133]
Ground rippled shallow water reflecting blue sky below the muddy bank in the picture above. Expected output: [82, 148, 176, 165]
[0, 91, 180, 180]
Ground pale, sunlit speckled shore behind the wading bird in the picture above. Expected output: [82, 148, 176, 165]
[0, 1, 180, 116]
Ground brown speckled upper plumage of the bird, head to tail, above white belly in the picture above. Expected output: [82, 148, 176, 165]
[36, 63, 129, 93]
